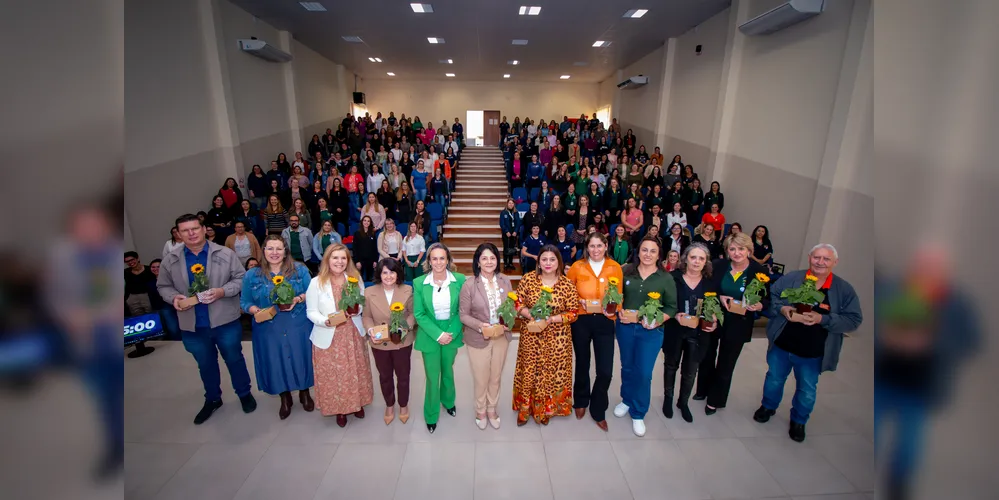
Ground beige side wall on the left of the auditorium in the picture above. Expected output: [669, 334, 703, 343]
[124, 0, 353, 259]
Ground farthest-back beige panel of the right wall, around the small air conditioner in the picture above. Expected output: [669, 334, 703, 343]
[613, 46, 666, 152]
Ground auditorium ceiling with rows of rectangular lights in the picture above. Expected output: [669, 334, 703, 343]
[230, 0, 731, 83]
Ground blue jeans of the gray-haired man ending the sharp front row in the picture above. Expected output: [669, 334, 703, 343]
[763, 345, 822, 425]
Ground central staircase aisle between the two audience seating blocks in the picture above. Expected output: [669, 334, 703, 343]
[442, 147, 520, 287]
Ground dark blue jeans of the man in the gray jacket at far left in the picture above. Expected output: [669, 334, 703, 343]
[182, 320, 250, 401]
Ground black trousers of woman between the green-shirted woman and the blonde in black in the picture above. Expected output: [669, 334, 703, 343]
[663, 327, 710, 407]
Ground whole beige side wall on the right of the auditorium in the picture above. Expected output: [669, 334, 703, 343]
[615, 0, 874, 310]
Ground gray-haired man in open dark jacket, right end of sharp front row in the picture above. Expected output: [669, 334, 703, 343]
[753, 244, 864, 443]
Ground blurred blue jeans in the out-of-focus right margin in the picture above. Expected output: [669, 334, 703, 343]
[874, 383, 931, 484]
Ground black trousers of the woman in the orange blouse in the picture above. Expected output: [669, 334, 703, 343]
[572, 314, 614, 422]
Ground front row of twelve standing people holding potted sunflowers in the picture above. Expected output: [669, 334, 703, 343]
[157, 209, 860, 439]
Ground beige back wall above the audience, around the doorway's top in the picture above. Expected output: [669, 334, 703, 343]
[361, 79, 598, 127]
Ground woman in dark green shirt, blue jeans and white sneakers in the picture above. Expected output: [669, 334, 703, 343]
[614, 236, 676, 437]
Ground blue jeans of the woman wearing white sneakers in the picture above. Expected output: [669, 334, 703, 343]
[617, 322, 663, 420]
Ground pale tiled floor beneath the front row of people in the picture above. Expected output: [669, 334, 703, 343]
[125, 332, 875, 500]
